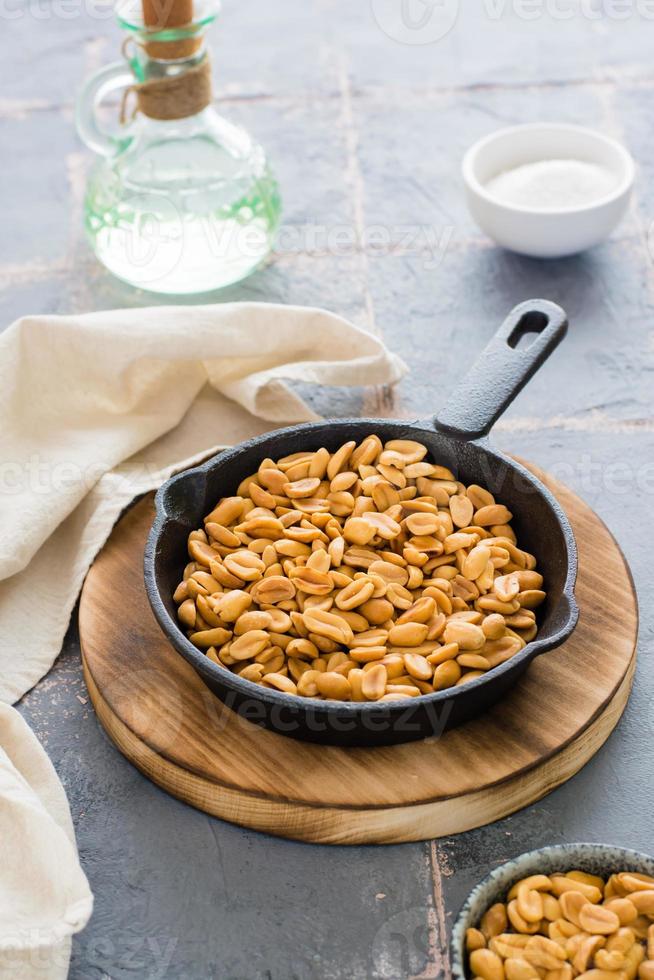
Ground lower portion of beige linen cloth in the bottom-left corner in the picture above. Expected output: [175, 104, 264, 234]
[0, 704, 93, 980]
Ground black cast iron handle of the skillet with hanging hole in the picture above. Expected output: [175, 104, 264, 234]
[434, 299, 568, 440]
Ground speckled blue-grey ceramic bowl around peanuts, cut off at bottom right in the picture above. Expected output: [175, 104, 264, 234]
[451, 844, 654, 980]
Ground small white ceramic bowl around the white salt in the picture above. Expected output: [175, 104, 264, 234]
[462, 123, 635, 259]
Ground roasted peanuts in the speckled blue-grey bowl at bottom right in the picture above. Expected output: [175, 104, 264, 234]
[466, 871, 654, 980]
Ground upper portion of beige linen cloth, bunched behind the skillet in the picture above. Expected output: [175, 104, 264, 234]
[0, 303, 405, 703]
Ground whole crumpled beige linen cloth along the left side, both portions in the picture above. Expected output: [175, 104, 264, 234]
[0, 304, 404, 980]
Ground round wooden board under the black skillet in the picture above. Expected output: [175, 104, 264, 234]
[79, 467, 638, 844]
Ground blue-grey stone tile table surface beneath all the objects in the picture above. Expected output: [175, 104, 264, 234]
[0, 0, 654, 980]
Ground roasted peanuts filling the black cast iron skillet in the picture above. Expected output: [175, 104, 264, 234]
[174, 435, 545, 701]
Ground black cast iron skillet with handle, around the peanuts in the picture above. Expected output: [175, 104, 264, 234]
[145, 300, 578, 746]
